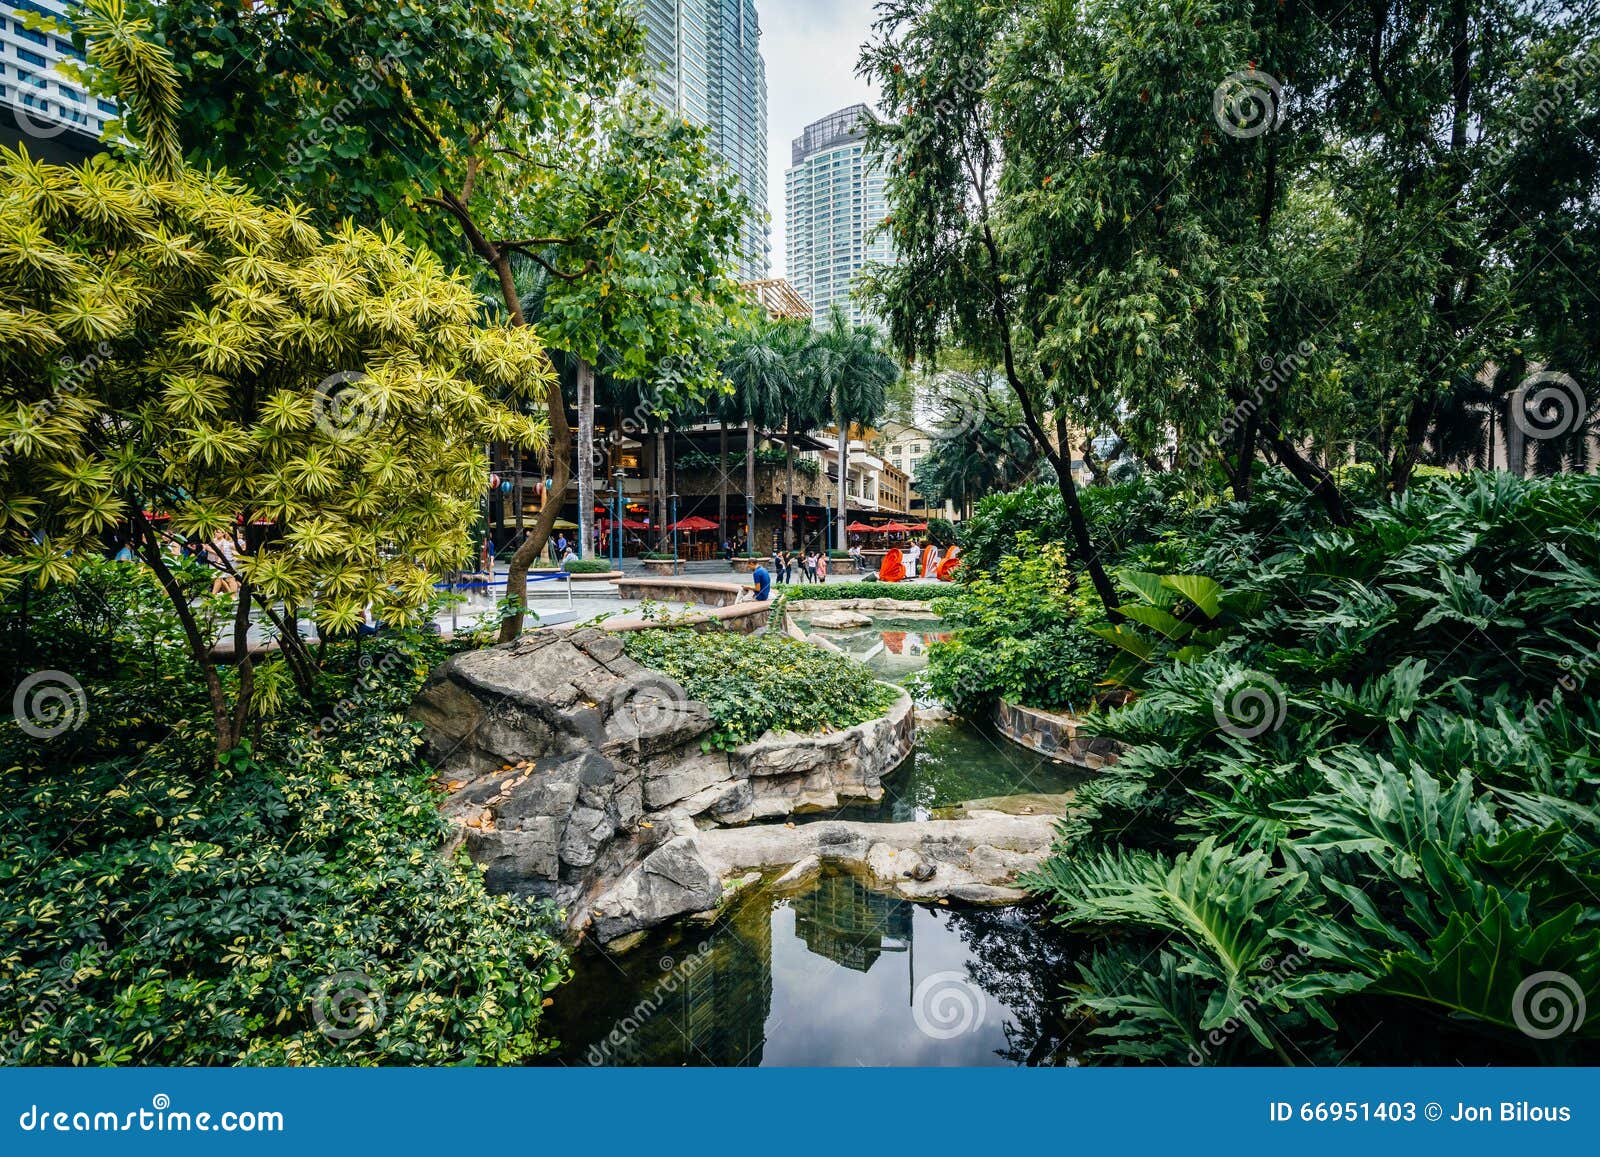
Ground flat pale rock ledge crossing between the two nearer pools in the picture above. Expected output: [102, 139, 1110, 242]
[590, 810, 1059, 941]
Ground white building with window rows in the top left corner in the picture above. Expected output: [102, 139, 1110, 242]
[0, 0, 117, 163]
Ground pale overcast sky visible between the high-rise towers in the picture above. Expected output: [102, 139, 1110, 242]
[757, 0, 877, 277]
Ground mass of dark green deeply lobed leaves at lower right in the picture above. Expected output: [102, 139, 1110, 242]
[1027, 474, 1600, 1064]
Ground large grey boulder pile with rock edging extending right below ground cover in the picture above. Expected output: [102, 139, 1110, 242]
[411, 629, 915, 927]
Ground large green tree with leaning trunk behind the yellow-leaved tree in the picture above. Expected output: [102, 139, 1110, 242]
[116, 0, 742, 639]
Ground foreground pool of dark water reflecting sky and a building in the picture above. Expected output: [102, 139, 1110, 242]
[549, 875, 1072, 1066]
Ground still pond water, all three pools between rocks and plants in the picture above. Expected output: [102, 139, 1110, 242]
[546, 618, 1090, 1066]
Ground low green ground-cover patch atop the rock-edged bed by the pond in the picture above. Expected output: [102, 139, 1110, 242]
[626, 631, 896, 749]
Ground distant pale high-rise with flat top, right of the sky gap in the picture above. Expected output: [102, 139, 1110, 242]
[784, 104, 894, 325]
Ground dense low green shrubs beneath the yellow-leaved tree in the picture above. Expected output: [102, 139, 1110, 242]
[0, 579, 570, 1066]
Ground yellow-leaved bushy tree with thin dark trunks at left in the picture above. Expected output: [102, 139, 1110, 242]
[0, 0, 550, 752]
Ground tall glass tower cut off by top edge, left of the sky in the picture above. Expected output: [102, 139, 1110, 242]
[640, 0, 771, 282]
